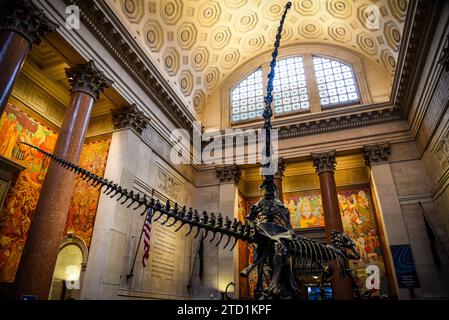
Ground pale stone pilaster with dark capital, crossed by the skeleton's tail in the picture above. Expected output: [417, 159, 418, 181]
[216, 165, 241, 299]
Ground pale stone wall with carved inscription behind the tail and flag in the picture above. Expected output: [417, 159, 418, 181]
[81, 129, 198, 299]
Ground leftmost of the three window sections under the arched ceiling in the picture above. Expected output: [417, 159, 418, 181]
[231, 68, 264, 122]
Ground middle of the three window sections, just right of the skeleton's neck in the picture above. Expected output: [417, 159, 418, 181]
[273, 57, 310, 113]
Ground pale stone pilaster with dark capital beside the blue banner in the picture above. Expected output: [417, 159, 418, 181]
[363, 143, 410, 299]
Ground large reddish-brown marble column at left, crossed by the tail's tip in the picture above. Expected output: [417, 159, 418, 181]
[15, 61, 112, 299]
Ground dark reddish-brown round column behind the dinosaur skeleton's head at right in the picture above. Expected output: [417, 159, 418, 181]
[312, 150, 354, 300]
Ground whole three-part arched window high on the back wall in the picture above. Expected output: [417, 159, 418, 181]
[230, 53, 362, 124]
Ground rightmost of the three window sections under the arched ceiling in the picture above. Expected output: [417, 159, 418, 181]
[313, 56, 359, 106]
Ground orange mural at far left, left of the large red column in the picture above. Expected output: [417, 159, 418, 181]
[0, 104, 57, 283]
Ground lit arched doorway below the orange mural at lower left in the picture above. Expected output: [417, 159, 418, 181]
[49, 237, 87, 300]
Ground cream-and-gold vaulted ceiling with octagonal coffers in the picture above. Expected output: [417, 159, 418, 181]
[106, 0, 408, 112]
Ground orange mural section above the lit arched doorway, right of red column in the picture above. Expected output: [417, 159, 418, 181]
[64, 140, 110, 246]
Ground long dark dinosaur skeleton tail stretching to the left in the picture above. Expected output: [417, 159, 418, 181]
[21, 142, 255, 250]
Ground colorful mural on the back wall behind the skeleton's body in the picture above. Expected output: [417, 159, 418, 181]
[239, 185, 388, 298]
